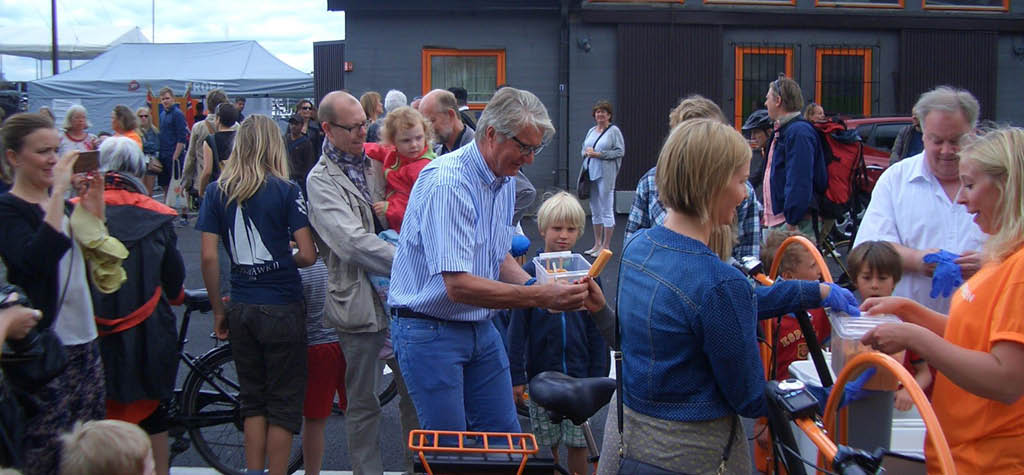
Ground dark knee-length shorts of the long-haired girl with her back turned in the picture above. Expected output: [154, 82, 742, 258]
[226, 302, 306, 434]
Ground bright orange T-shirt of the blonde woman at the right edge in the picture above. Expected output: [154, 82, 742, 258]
[925, 249, 1024, 474]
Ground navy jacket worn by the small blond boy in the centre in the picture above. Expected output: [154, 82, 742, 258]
[508, 251, 610, 386]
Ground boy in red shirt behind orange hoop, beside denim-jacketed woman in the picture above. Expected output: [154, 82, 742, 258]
[761, 230, 831, 381]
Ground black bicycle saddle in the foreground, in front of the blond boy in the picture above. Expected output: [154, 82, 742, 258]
[529, 372, 615, 425]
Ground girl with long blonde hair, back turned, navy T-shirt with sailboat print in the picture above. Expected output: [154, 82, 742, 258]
[196, 115, 316, 475]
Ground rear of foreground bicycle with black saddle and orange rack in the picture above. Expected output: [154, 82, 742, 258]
[408, 372, 615, 475]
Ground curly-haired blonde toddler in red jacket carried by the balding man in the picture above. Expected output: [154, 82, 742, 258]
[362, 105, 437, 232]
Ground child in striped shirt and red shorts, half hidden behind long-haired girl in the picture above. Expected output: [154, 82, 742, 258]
[299, 255, 347, 475]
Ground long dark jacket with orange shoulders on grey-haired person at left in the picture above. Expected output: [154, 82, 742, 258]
[92, 172, 185, 402]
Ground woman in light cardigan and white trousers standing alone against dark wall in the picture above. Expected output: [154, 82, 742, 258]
[581, 100, 626, 256]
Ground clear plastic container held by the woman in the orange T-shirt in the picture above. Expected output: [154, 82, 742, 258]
[828, 311, 903, 391]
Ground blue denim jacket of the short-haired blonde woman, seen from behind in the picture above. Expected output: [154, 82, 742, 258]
[618, 226, 766, 422]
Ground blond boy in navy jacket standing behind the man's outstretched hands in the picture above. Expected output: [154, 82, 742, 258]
[509, 191, 609, 474]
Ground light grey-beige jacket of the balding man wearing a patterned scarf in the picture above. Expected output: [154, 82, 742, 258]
[306, 156, 394, 333]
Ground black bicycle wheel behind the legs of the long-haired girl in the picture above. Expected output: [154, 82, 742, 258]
[181, 345, 302, 475]
